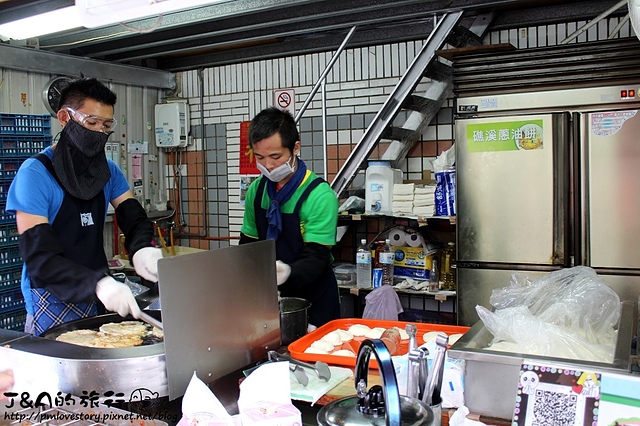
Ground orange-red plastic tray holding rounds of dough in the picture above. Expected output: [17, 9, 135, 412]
[288, 318, 469, 367]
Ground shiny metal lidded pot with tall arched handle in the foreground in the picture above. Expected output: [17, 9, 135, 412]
[317, 339, 435, 426]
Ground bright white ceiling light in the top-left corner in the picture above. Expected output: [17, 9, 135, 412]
[0, 6, 82, 40]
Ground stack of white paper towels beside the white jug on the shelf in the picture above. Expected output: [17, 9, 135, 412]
[391, 183, 436, 217]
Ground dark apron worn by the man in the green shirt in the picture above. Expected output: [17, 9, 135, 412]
[254, 177, 340, 327]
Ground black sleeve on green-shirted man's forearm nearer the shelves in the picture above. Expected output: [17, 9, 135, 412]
[280, 243, 331, 291]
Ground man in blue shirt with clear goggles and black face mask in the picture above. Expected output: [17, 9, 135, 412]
[6, 78, 162, 336]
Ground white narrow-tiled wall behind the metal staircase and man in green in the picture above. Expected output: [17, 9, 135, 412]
[179, 18, 631, 247]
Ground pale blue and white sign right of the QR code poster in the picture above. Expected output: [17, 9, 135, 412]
[598, 373, 640, 426]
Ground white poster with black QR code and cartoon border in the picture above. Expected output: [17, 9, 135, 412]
[512, 363, 600, 426]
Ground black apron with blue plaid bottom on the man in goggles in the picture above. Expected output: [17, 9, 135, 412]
[31, 154, 108, 336]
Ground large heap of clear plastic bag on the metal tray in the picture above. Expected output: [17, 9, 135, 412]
[476, 266, 620, 363]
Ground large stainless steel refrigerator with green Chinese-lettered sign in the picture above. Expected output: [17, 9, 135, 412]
[455, 82, 640, 325]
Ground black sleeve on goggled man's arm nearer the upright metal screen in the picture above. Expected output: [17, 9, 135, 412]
[116, 198, 153, 265]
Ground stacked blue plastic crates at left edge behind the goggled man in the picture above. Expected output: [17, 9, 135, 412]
[0, 113, 51, 330]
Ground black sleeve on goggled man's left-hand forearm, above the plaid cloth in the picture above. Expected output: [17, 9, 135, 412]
[19, 223, 105, 303]
